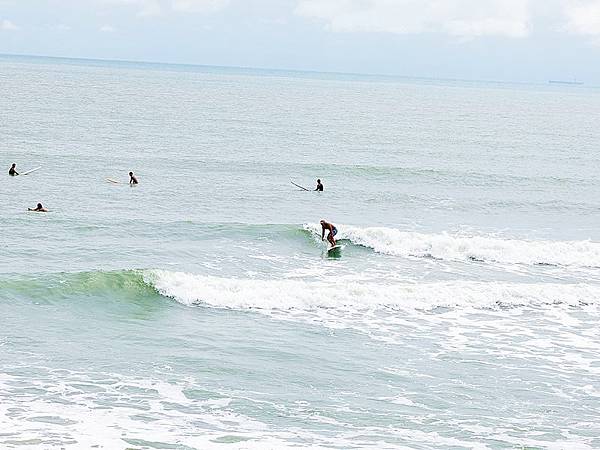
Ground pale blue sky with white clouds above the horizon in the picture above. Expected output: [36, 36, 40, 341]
[0, 0, 600, 85]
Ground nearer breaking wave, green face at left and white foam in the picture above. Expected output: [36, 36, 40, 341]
[5, 269, 600, 315]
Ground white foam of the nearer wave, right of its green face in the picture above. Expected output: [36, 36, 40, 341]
[143, 270, 600, 313]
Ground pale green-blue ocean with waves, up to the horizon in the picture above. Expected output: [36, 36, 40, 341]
[0, 56, 600, 450]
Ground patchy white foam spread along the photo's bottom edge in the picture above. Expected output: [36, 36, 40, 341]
[0, 367, 595, 450]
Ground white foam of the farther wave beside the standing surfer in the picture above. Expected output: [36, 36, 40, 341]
[304, 224, 600, 267]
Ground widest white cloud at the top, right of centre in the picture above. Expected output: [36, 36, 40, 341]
[295, 0, 531, 38]
